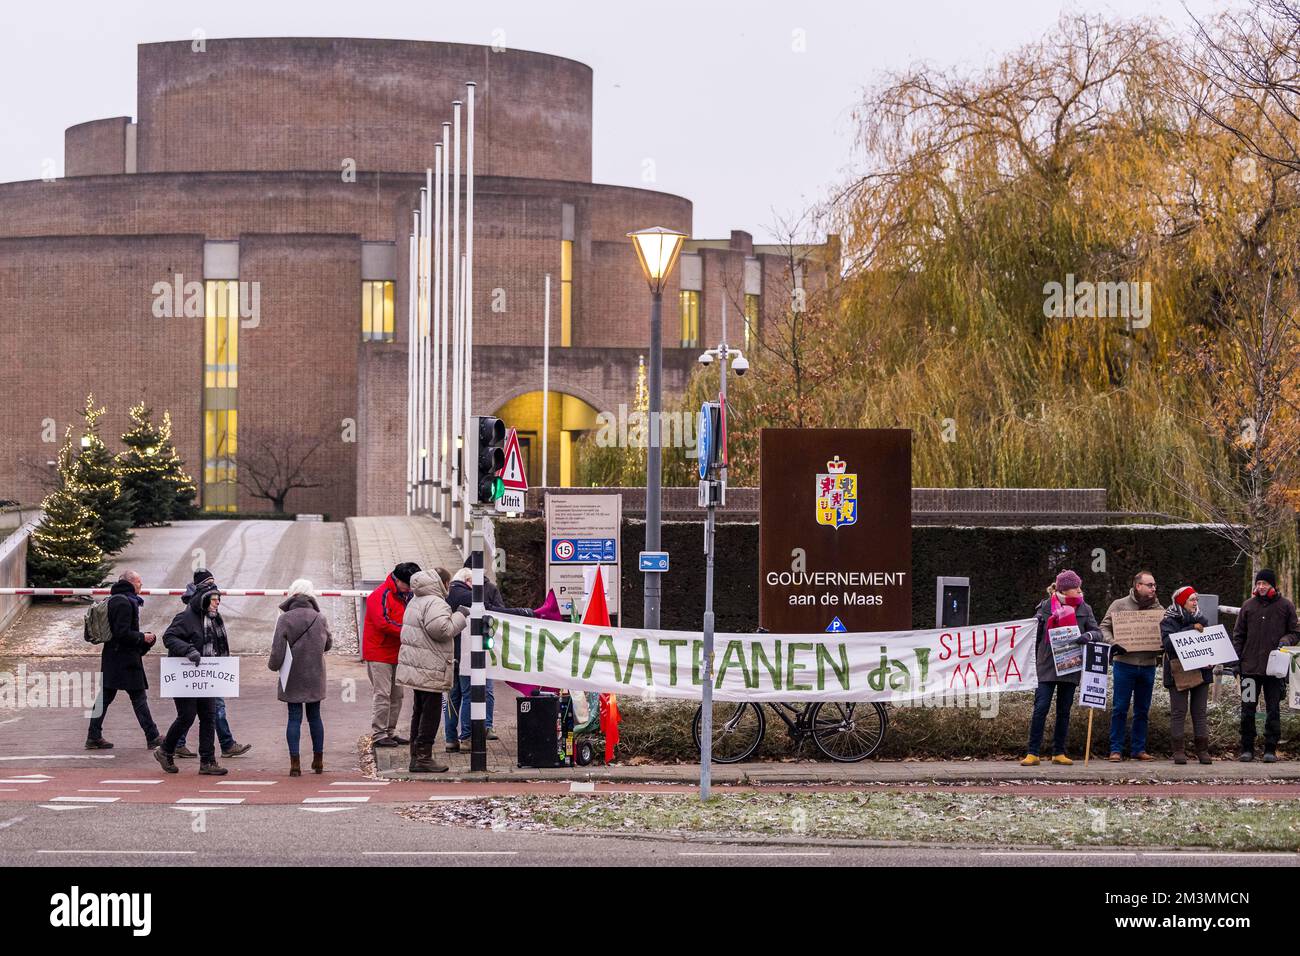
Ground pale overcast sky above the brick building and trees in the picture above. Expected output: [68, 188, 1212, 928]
[0, 0, 1235, 241]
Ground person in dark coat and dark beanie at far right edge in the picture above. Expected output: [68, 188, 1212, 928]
[1232, 568, 1300, 763]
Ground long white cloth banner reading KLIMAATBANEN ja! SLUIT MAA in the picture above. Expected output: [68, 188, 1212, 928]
[488, 614, 1040, 704]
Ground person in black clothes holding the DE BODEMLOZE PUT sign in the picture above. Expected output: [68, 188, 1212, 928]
[153, 585, 229, 777]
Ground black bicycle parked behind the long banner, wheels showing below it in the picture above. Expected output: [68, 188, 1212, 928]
[690, 701, 889, 763]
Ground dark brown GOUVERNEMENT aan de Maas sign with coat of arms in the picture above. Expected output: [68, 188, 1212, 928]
[758, 428, 911, 633]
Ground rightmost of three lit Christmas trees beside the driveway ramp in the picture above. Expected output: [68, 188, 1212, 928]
[117, 402, 198, 527]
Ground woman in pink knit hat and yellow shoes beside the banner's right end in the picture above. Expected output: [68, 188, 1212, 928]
[1021, 571, 1101, 767]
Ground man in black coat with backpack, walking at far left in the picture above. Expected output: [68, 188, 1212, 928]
[86, 571, 163, 750]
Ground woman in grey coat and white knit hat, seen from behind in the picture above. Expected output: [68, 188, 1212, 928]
[267, 578, 334, 777]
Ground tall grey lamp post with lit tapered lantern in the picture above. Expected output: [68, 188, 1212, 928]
[628, 226, 686, 628]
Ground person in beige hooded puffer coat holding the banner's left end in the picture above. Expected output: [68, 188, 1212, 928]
[397, 567, 465, 774]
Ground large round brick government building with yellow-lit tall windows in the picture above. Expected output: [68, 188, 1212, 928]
[0, 39, 839, 518]
